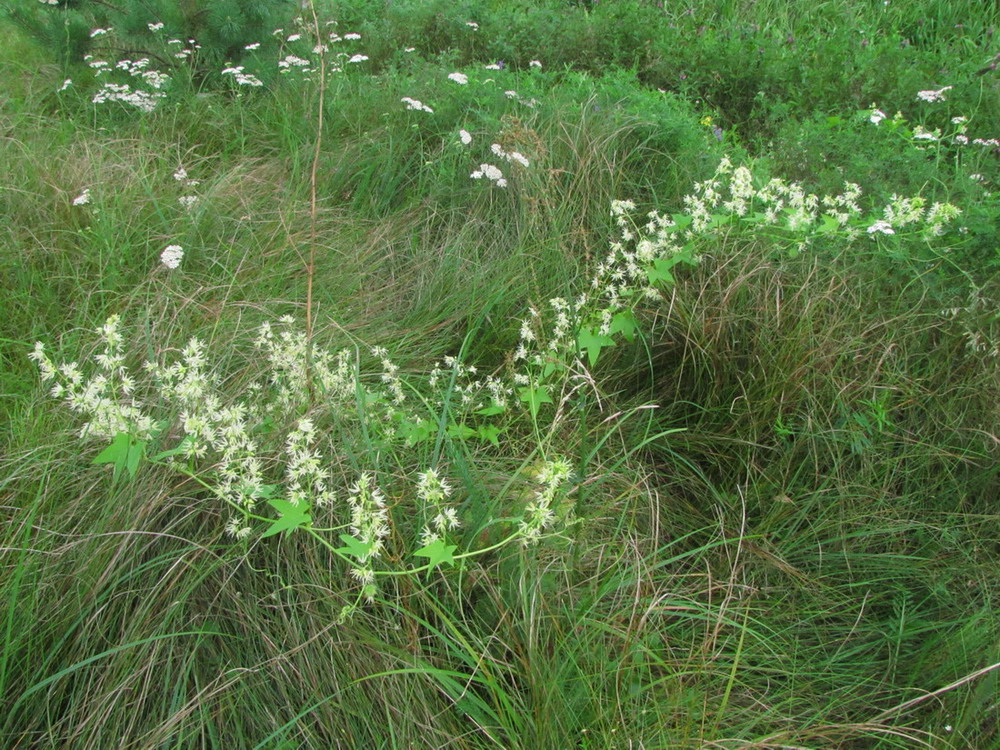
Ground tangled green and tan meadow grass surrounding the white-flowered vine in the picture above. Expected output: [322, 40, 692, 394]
[0, 2, 1000, 749]
